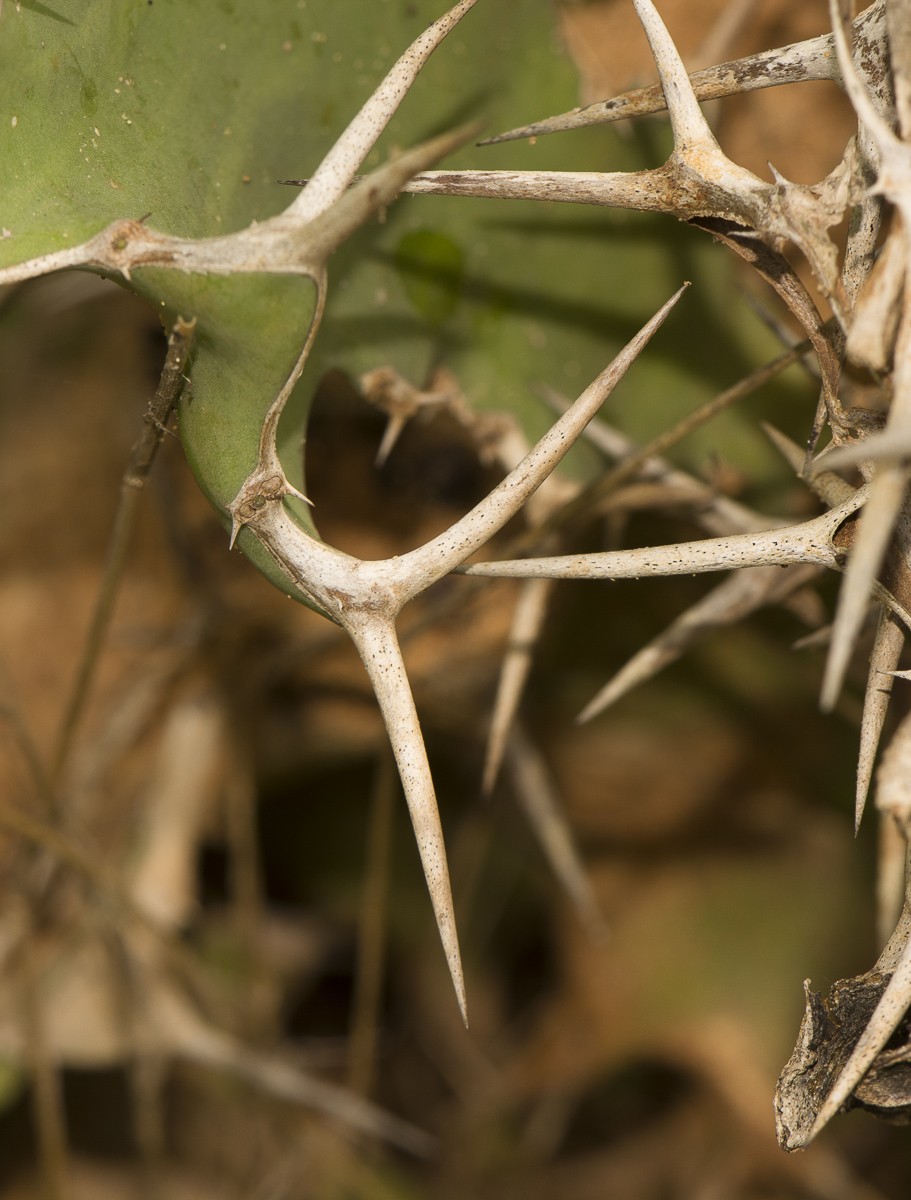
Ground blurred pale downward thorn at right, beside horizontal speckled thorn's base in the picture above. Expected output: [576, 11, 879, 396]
[820, 467, 909, 713]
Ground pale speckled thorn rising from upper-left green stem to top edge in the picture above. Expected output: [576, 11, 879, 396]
[294, 0, 478, 221]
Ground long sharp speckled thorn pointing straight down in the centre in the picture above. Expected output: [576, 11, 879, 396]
[344, 612, 468, 1028]
